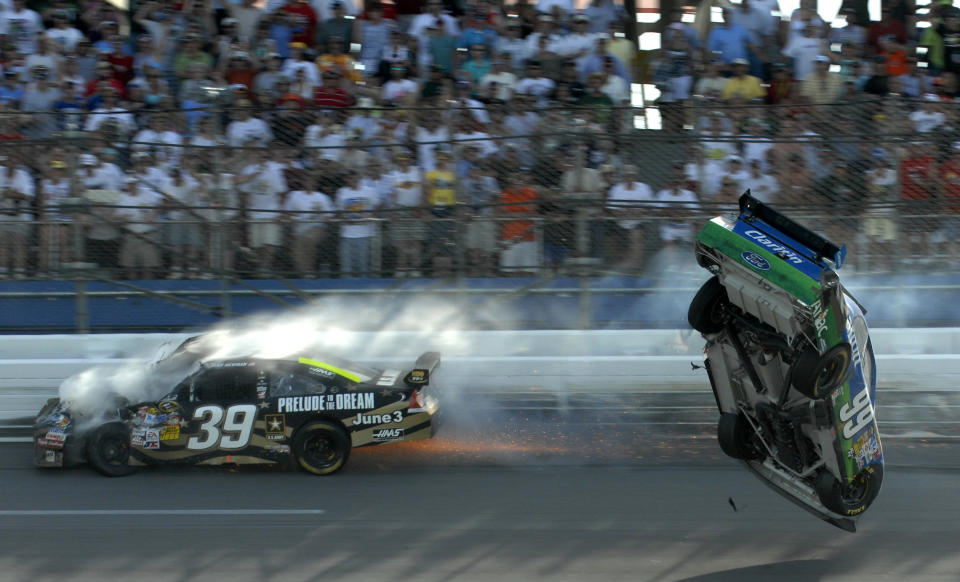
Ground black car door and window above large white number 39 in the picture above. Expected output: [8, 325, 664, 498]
[184, 361, 263, 457]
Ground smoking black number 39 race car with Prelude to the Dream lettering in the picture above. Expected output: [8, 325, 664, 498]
[34, 338, 440, 477]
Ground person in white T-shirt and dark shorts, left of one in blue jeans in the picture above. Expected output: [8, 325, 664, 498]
[283, 175, 335, 279]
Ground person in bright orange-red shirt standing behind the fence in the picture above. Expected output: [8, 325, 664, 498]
[499, 166, 540, 274]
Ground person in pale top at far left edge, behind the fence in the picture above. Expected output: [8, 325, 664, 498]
[0, 151, 35, 279]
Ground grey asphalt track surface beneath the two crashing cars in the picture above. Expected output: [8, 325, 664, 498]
[0, 396, 960, 582]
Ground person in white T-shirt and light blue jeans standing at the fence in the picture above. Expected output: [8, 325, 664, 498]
[335, 170, 380, 277]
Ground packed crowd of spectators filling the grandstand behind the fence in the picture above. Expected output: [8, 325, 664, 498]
[0, 0, 960, 278]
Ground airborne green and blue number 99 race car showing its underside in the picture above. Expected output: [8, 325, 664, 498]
[688, 190, 883, 531]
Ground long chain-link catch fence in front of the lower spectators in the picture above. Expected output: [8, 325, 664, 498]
[0, 100, 960, 280]
